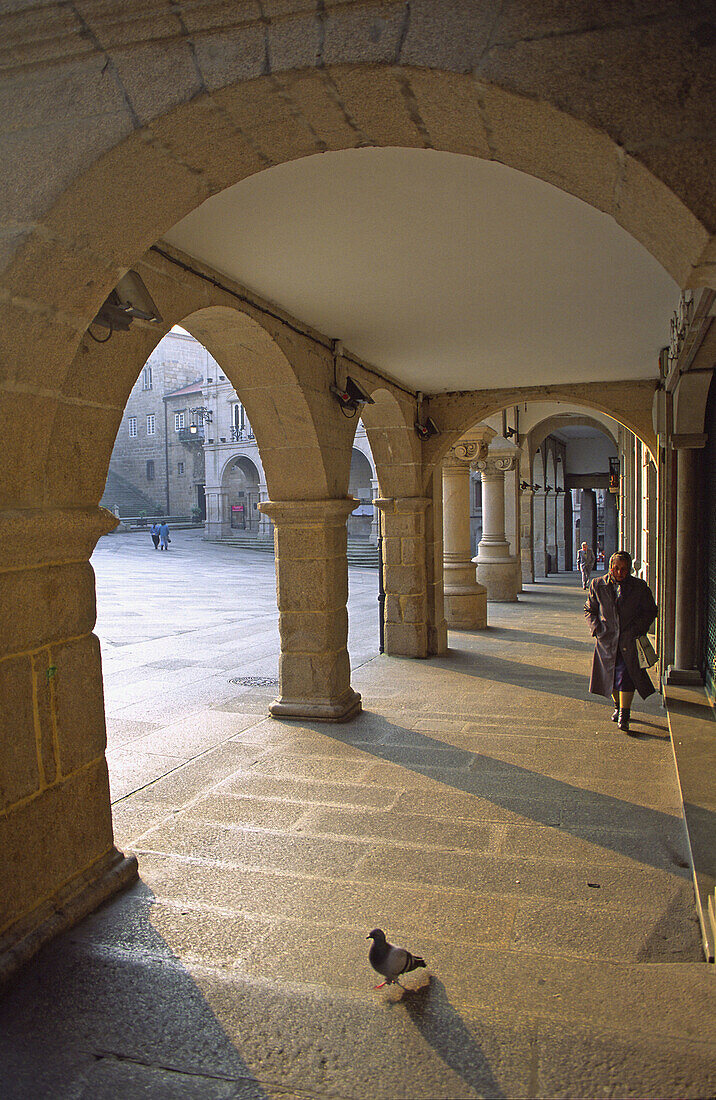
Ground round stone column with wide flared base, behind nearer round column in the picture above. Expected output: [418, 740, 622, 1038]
[475, 441, 518, 603]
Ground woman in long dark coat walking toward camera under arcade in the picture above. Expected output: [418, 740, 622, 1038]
[584, 550, 657, 734]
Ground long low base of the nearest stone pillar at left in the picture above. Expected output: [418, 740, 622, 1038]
[0, 848, 139, 987]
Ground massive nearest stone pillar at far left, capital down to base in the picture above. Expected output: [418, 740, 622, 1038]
[0, 507, 136, 980]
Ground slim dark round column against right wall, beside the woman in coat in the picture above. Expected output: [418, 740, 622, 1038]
[669, 447, 702, 683]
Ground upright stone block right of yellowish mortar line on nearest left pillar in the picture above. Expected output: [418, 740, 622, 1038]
[52, 635, 107, 776]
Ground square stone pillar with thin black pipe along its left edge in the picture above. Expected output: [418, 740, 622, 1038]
[374, 495, 447, 657]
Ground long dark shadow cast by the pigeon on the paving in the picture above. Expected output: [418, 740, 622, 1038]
[393, 975, 505, 1098]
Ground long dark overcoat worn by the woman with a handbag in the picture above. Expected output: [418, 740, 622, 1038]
[584, 573, 657, 699]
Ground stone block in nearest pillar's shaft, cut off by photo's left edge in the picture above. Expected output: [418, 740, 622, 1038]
[0, 657, 40, 810]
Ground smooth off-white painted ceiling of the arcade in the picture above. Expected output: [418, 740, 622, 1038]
[166, 149, 679, 393]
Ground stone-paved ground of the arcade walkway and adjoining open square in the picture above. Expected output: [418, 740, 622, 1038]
[0, 532, 716, 1100]
